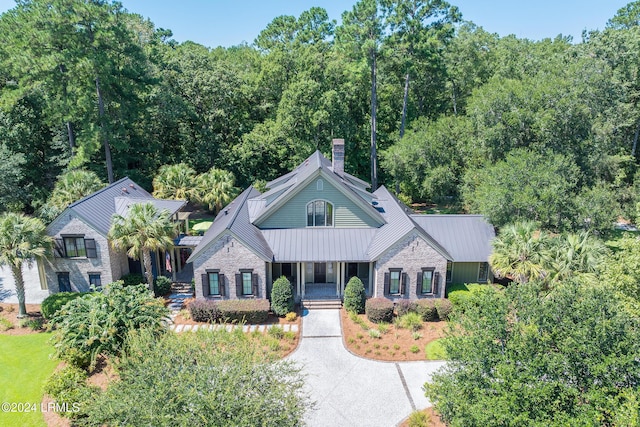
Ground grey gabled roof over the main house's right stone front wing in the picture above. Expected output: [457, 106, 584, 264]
[368, 185, 453, 260]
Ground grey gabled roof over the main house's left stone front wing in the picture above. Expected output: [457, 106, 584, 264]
[187, 187, 273, 262]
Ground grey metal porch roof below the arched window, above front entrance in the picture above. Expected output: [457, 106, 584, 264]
[262, 227, 377, 262]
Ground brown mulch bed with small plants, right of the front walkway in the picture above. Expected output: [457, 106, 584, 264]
[340, 309, 447, 362]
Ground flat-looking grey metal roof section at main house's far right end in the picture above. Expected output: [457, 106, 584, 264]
[411, 215, 496, 262]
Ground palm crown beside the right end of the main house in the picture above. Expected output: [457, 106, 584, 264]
[489, 222, 549, 283]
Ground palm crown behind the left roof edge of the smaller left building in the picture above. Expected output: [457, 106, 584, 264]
[48, 170, 105, 212]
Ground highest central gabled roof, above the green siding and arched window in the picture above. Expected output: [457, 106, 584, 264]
[249, 150, 384, 225]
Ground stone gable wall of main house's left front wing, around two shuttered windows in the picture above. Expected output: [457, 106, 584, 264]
[193, 234, 267, 299]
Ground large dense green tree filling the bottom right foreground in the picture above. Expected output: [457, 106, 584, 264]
[425, 281, 640, 426]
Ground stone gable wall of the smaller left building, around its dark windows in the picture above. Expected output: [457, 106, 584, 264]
[44, 211, 129, 293]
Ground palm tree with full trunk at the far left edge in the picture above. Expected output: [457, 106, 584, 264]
[0, 212, 53, 317]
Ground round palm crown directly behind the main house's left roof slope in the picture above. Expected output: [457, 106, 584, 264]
[194, 168, 238, 213]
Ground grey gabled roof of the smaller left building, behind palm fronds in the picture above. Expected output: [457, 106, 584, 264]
[52, 177, 186, 236]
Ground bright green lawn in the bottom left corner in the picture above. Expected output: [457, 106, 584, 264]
[0, 333, 58, 427]
